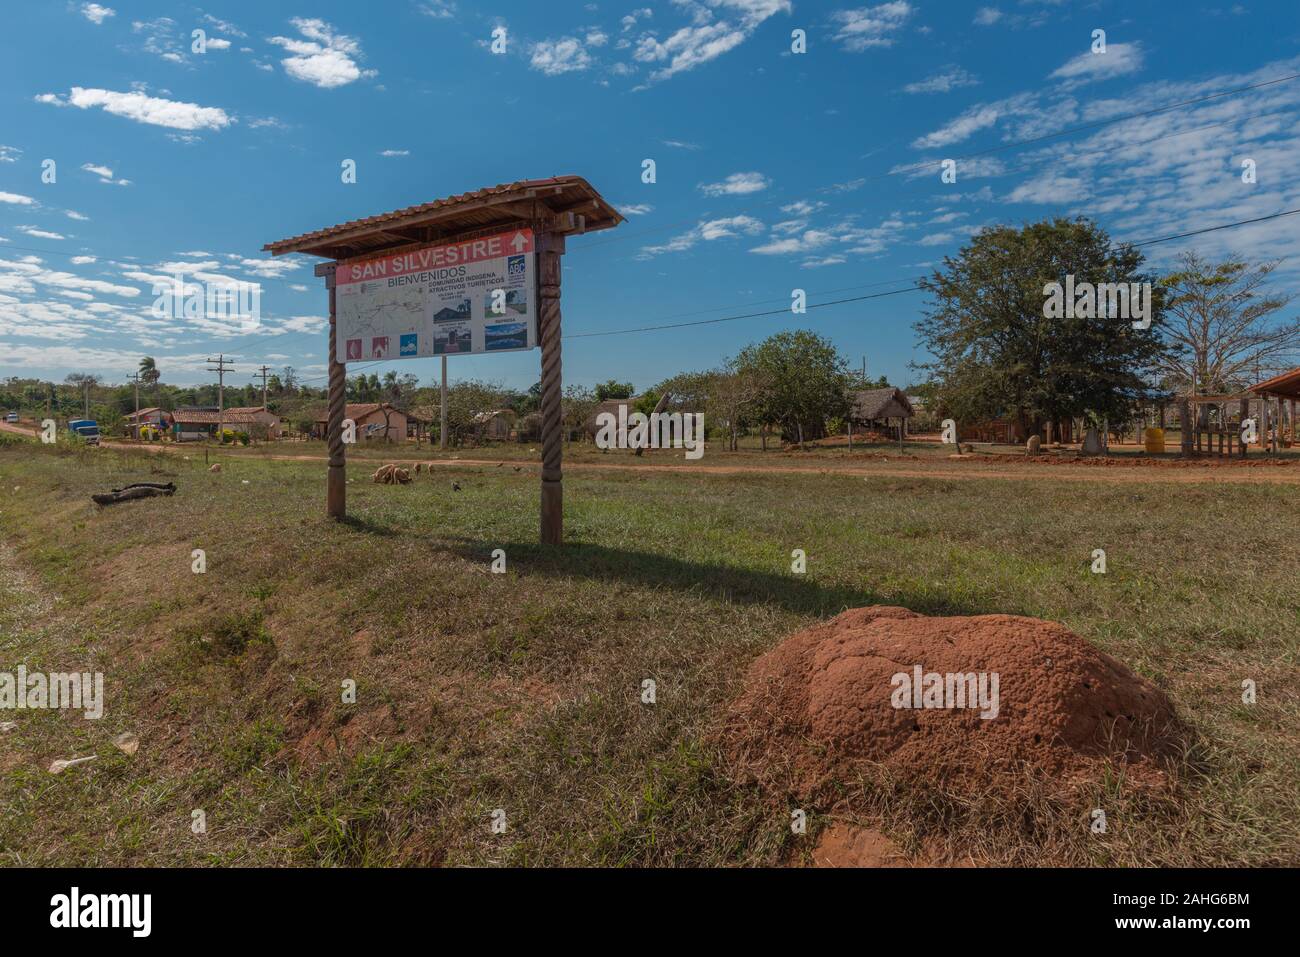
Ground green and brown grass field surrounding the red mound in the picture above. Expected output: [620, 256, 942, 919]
[0, 442, 1300, 866]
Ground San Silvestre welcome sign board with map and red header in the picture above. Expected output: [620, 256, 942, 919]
[334, 229, 537, 363]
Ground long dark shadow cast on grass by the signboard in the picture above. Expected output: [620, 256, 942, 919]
[446, 537, 992, 616]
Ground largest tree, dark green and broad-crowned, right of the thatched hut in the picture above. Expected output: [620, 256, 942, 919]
[915, 218, 1164, 432]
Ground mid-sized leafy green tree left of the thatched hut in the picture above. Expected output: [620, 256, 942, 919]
[733, 329, 849, 446]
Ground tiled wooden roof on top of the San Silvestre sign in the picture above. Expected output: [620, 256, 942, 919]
[263, 176, 623, 260]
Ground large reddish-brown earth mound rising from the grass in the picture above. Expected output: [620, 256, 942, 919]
[725, 606, 1180, 794]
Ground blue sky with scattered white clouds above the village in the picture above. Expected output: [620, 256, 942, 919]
[0, 0, 1300, 389]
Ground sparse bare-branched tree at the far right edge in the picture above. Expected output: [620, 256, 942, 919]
[1161, 252, 1300, 395]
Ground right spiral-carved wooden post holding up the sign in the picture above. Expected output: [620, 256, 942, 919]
[537, 233, 564, 545]
